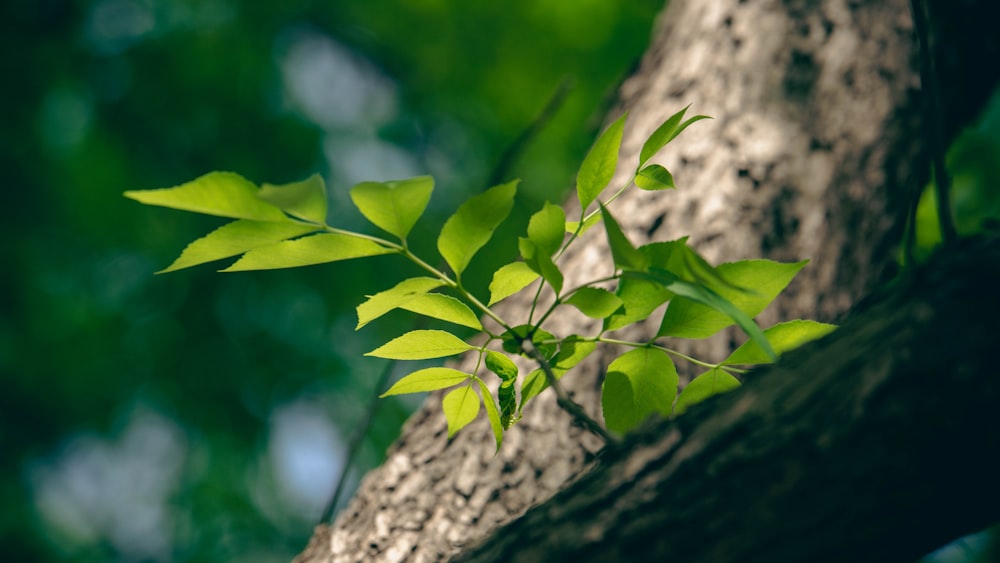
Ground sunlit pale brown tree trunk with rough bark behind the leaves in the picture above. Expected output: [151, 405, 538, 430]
[299, 0, 917, 562]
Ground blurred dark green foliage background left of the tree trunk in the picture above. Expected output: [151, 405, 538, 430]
[0, 0, 662, 562]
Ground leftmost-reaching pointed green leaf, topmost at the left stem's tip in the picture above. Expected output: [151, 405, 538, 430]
[125, 172, 289, 221]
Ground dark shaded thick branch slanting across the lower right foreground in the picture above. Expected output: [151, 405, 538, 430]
[457, 236, 1000, 563]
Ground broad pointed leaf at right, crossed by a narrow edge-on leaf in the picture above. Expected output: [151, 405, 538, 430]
[657, 260, 808, 338]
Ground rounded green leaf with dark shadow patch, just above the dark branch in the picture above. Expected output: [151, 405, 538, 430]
[601, 348, 678, 433]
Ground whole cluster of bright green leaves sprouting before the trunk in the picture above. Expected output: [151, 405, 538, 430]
[125, 104, 834, 449]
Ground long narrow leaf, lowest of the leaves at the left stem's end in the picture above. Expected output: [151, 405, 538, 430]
[222, 233, 395, 272]
